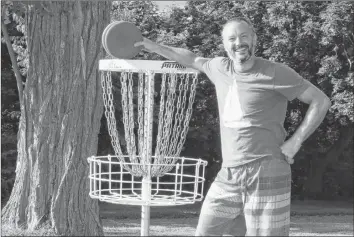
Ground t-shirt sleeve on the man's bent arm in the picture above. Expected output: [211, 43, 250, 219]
[274, 64, 309, 101]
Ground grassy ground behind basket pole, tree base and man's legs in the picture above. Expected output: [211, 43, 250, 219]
[1, 201, 353, 236]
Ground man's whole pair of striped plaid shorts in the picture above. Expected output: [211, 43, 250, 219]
[196, 158, 291, 236]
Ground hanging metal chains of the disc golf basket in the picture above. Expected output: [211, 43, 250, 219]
[101, 72, 198, 177]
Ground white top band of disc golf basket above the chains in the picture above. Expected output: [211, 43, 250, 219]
[99, 59, 199, 73]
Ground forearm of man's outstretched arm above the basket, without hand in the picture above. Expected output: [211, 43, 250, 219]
[153, 44, 197, 67]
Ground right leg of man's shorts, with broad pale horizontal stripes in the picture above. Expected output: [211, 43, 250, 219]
[244, 158, 291, 236]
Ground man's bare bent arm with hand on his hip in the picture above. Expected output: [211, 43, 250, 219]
[281, 79, 331, 164]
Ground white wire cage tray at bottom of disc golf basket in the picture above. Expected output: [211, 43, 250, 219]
[88, 156, 207, 206]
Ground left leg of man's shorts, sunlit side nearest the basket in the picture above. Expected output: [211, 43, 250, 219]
[195, 168, 245, 236]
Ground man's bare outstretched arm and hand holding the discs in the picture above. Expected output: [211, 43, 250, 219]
[135, 38, 208, 72]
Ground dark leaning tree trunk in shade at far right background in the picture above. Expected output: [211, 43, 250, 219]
[303, 124, 353, 198]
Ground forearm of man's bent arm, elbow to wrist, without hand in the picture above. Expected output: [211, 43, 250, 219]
[291, 102, 330, 144]
